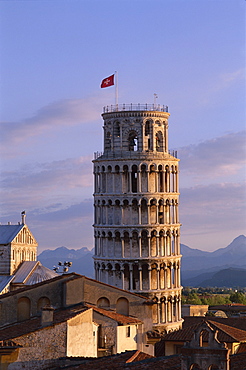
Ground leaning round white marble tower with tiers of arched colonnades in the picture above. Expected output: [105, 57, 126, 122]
[93, 104, 182, 332]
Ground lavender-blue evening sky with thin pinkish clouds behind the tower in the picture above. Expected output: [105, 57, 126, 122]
[0, 0, 246, 253]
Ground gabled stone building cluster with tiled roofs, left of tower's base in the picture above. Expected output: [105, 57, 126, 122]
[0, 273, 160, 369]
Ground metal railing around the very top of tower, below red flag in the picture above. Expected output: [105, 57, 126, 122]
[103, 103, 168, 113]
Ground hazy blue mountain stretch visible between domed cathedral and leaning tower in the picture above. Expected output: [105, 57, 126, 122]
[38, 247, 94, 278]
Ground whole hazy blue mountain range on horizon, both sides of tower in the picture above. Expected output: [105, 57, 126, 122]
[38, 235, 246, 287]
